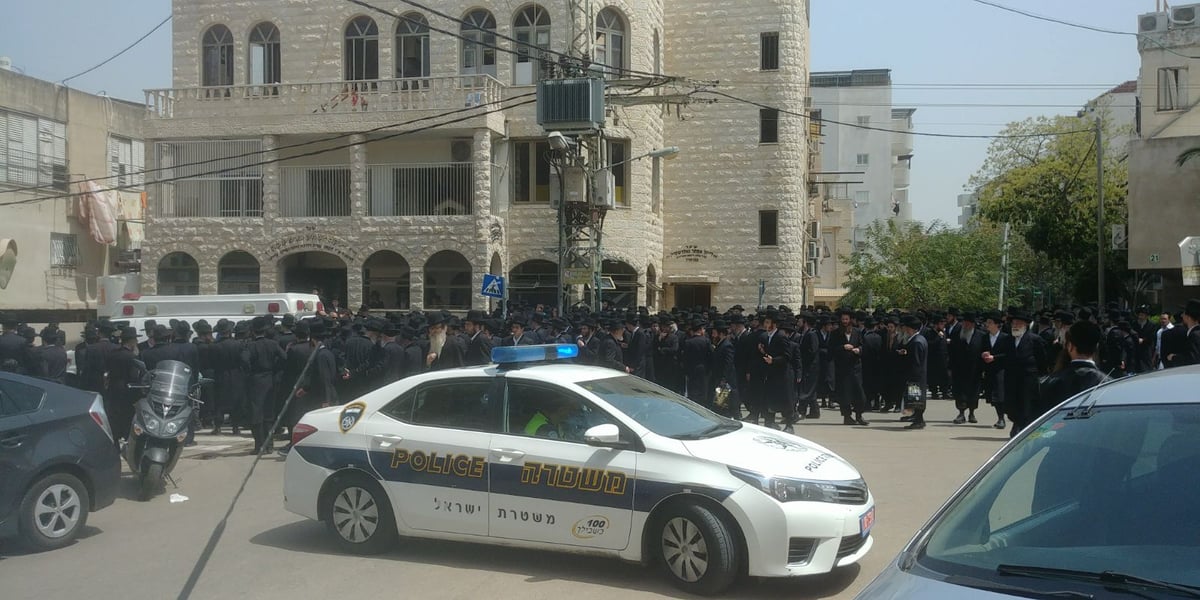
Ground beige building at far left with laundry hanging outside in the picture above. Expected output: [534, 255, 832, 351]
[0, 68, 145, 324]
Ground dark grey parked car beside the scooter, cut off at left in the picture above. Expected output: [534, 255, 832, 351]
[0, 373, 121, 550]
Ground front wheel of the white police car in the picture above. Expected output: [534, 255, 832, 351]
[659, 505, 738, 595]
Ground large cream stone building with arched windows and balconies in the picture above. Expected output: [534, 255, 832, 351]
[143, 0, 808, 311]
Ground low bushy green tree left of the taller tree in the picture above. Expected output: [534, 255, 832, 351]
[841, 221, 1012, 310]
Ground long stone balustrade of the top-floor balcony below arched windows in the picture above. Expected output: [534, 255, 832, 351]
[145, 74, 504, 119]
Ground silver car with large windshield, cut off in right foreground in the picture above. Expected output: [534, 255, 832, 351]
[858, 367, 1200, 600]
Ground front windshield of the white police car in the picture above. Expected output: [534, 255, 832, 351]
[578, 376, 742, 439]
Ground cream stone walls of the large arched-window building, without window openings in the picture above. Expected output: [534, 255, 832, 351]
[143, 0, 808, 310]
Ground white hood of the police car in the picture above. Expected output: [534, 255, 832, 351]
[683, 425, 862, 481]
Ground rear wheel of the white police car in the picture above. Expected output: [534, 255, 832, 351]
[325, 476, 396, 554]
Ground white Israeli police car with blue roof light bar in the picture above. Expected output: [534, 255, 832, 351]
[284, 344, 875, 594]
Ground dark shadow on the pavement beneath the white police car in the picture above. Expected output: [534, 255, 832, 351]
[250, 521, 860, 599]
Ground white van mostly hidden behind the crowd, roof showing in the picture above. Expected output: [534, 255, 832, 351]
[112, 293, 325, 341]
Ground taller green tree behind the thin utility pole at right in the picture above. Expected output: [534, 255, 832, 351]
[968, 116, 1128, 300]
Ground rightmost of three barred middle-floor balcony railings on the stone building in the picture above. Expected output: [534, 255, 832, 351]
[367, 162, 475, 217]
